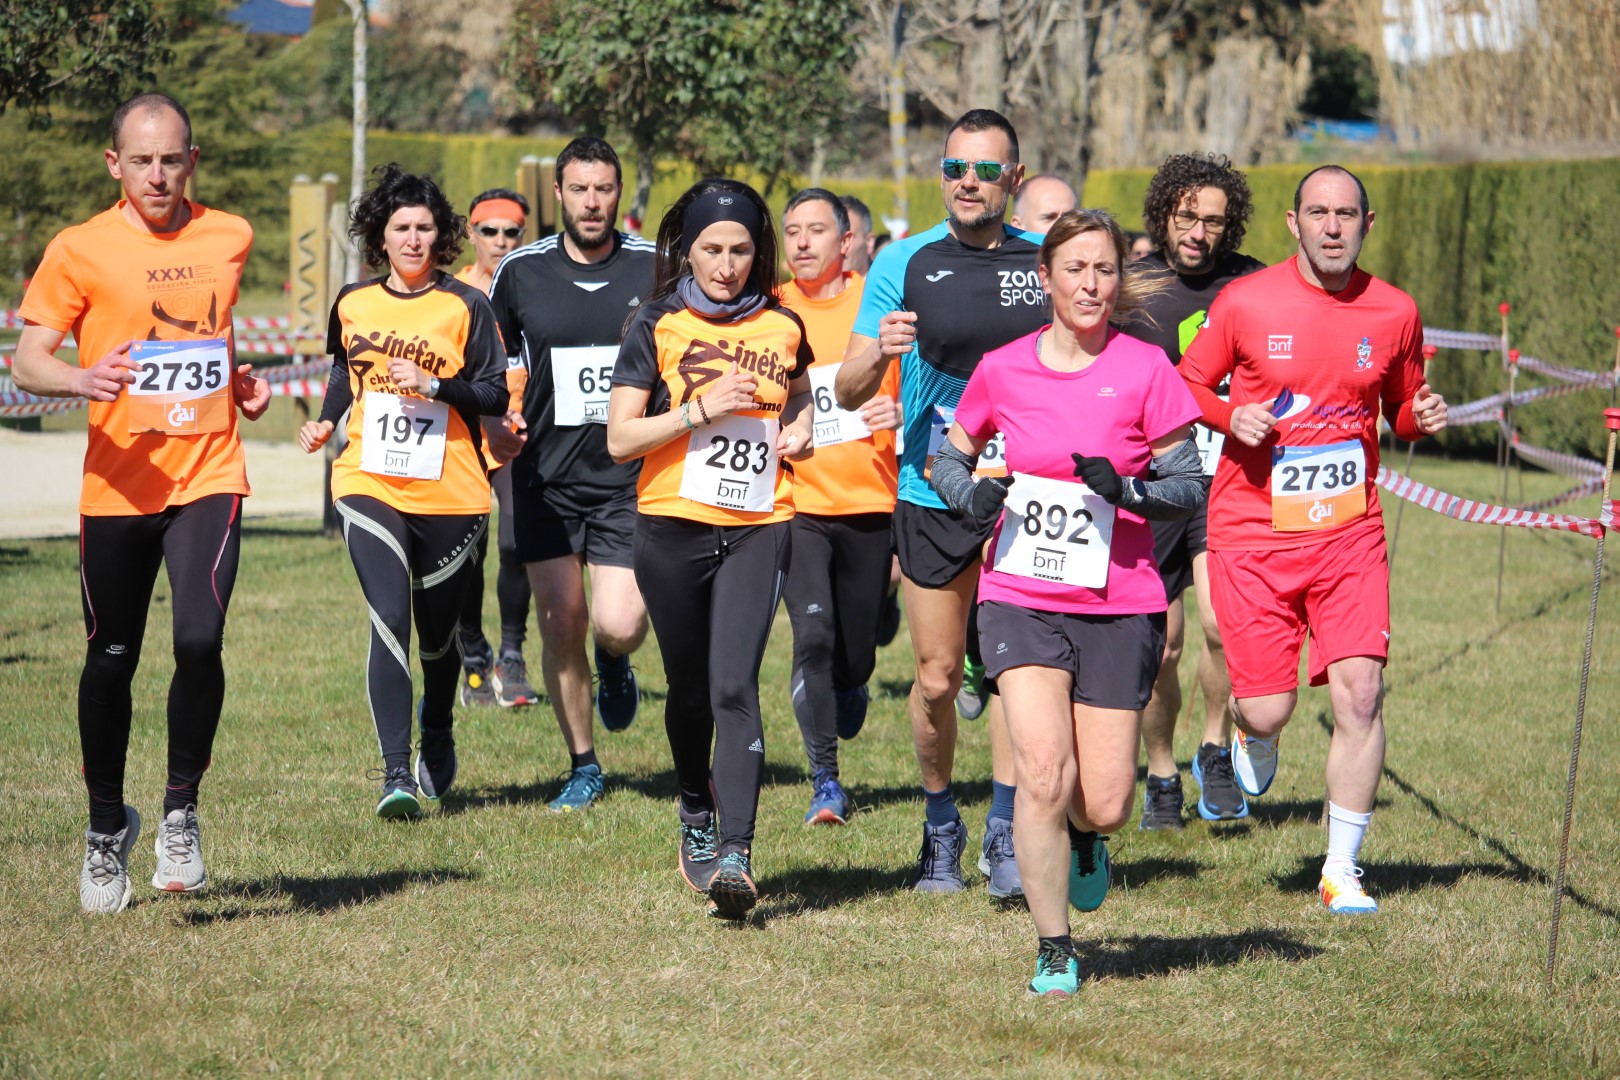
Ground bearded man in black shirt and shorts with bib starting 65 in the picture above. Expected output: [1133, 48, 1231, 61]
[492, 136, 654, 813]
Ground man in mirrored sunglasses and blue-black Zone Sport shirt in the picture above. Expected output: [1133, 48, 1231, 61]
[836, 108, 1050, 900]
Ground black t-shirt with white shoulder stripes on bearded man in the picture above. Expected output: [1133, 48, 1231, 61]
[489, 233, 656, 494]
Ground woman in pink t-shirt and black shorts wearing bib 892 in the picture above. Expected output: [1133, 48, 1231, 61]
[933, 210, 1204, 996]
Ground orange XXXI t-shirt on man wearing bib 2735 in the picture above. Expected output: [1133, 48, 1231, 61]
[19, 201, 253, 518]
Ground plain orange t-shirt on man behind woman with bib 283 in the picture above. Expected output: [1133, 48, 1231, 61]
[781, 274, 901, 517]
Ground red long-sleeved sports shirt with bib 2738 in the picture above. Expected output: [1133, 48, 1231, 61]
[1179, 257, 1424, 551]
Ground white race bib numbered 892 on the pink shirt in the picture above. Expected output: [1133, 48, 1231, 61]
[991, 473, 1115, 589]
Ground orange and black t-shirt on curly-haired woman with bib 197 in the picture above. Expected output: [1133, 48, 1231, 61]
[321, 274, 505, 515]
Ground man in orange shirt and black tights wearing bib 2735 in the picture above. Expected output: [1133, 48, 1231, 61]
[13, 94, 271, 913]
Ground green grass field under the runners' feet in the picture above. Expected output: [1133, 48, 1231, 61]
[0, 460, 1620, 1077]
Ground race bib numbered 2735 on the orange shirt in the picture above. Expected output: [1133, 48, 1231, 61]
[128, 337, 233, 436]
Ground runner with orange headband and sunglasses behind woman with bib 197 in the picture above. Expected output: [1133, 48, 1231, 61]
[455, 188, 539, 708]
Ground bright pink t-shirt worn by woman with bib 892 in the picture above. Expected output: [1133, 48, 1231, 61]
[956, 327, 1202, 615]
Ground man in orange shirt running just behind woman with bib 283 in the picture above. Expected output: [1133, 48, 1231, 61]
[781, 188, 899, 824]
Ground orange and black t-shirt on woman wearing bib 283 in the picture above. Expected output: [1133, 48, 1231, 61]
[612, 286, 812, 525]
